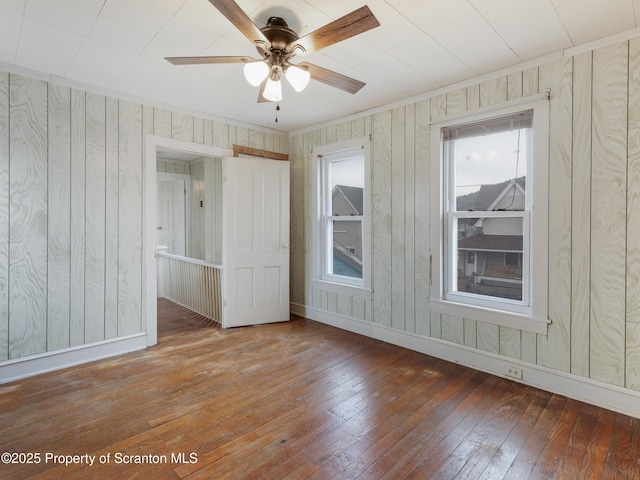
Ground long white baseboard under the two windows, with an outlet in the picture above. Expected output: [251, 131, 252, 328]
[291, 303, 640, 418]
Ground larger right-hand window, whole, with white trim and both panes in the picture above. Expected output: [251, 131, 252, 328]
[430, 101, 548, 333]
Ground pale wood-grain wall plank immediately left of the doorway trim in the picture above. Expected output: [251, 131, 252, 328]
[118, 101, 143, 336]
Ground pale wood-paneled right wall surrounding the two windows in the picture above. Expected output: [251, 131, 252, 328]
[290, 39, 640, 390]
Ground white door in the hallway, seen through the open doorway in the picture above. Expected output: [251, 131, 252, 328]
[157, 180, 186, 257]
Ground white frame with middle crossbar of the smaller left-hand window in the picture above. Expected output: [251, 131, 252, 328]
[311, 137, 372, 300]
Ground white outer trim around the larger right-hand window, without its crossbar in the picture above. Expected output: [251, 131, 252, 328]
[429, 94, 550, 334]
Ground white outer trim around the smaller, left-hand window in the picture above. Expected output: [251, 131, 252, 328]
[310, 137, 372, 300]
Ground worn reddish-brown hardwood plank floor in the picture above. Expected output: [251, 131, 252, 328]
[0, 300, 640, 480]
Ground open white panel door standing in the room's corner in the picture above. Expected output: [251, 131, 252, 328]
[222, 158, 289, 328]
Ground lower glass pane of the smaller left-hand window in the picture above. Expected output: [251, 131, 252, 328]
[333, 220, 362, 278]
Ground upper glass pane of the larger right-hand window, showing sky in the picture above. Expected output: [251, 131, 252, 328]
[450, 129, 530, 211]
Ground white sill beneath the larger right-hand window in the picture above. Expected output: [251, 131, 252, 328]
[429, 299, 550, 335]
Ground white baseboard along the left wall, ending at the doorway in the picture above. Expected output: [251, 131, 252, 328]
[0, 333, 147, 384]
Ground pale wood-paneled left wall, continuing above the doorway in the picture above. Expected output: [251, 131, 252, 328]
[0, 72, 289, 362]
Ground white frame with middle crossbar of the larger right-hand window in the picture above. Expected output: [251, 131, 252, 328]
[429, 94, 549, 334]
